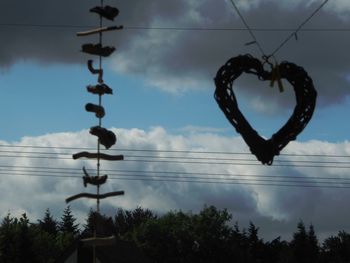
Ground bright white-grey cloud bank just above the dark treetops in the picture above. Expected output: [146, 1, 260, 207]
[0, 127, 350, 239]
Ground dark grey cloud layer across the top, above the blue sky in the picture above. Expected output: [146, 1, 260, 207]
[0, 0, 350, 111]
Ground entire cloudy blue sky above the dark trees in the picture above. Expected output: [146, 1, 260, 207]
[0, 0, 350, 242]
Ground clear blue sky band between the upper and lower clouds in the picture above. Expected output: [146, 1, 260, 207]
[0, 61, 350, 142]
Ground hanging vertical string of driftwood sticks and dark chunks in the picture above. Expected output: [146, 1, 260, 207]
[66, 0, 124, 256]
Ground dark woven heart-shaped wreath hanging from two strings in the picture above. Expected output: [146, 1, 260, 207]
[214, 55, 317, 165]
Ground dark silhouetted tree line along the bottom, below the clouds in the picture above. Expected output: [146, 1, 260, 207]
[0, 206, 350, 263]
